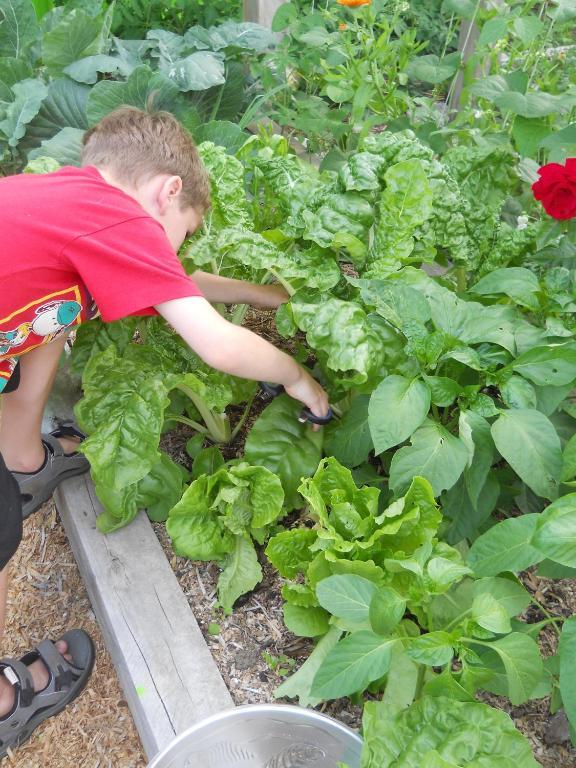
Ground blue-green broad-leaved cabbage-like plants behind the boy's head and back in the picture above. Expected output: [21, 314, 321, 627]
[0, 0, 275, 168]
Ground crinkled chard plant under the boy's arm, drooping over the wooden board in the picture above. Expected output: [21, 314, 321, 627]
[71, 320, 255, 532]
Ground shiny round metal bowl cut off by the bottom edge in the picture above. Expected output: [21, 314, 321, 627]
[148, 704, 362, 768]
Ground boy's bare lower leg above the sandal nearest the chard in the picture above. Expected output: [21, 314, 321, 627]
[0, 335, 78, 472]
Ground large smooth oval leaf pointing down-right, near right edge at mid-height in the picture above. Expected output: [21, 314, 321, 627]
[491, 408, 562, 499]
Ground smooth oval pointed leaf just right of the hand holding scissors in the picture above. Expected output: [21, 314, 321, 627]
[368, 376, 430, 456]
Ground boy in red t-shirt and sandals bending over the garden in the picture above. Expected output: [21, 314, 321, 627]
[0, 107, 328, 758]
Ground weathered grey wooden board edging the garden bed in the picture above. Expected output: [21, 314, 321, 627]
[55, 475, 233, 757]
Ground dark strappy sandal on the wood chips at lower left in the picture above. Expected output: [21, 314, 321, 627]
[0, 629, 95, 760]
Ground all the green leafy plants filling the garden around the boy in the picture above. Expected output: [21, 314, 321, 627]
[5, 0, 576, 768]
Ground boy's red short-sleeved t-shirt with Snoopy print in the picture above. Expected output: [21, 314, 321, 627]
[0, 166, 202, 392]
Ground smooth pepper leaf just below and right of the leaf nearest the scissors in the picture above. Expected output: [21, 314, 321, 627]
[390, 421, 468, 496]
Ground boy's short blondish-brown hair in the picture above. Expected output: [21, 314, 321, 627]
[81, 107, 210, 213]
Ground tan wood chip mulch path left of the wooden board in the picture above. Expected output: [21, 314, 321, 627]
[0, 502, 147, 768]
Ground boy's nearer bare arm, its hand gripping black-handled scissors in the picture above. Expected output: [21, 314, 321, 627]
[156, 296, 328, 416]
